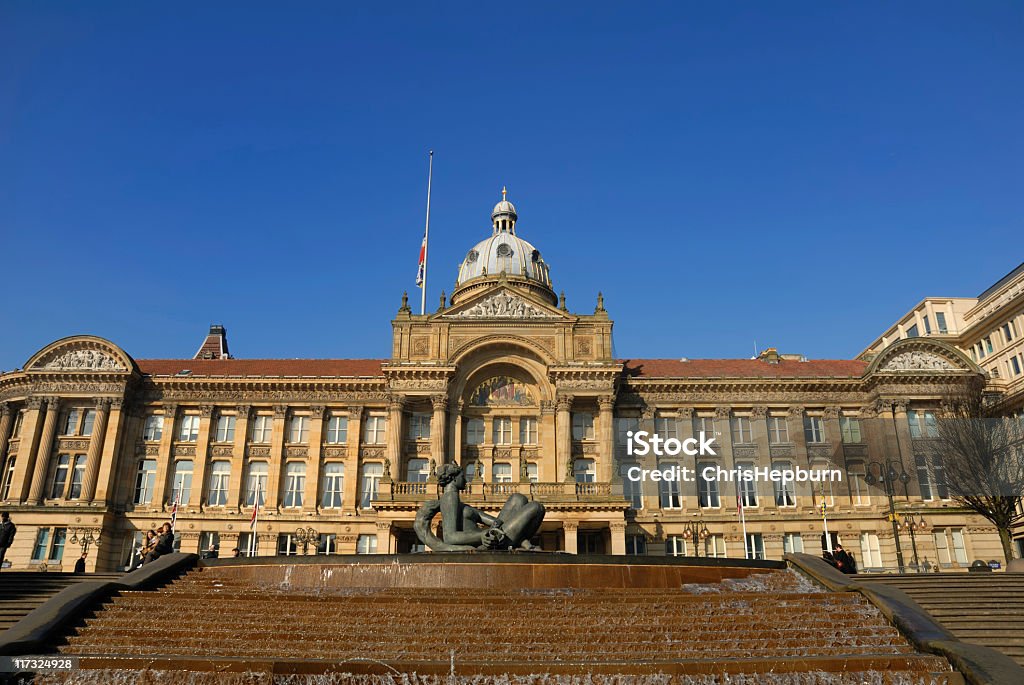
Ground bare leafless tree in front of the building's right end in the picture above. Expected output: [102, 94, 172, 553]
[929, 389, 1024, 562]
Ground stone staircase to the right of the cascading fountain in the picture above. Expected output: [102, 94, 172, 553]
[857, 573, 1024, 666]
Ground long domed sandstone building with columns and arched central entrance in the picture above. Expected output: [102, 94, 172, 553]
[0, 193, 999, 569]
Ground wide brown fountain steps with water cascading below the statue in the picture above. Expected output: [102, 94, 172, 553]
[44, 567, 963, 685]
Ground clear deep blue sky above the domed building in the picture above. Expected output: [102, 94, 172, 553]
[0, 0, 1024, 369]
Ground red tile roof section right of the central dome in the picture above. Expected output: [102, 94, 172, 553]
[623, 359, 867, 378]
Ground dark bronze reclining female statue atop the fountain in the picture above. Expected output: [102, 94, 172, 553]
[413, 464, 544, 552]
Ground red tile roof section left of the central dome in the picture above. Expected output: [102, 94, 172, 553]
[135, 359, 385, 377]
